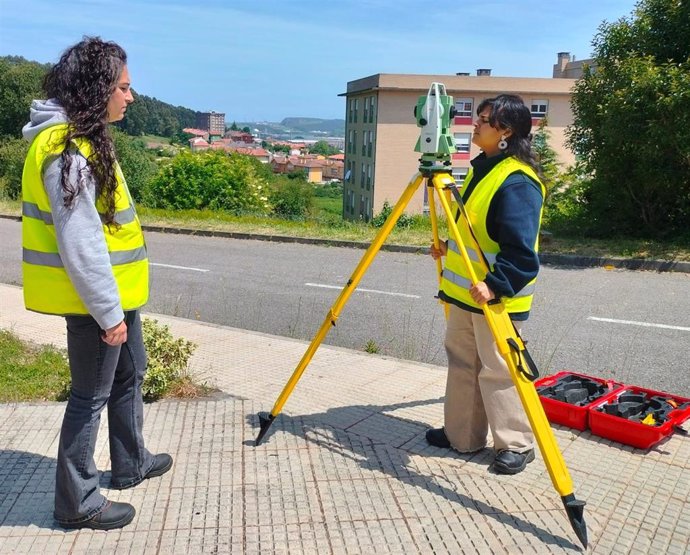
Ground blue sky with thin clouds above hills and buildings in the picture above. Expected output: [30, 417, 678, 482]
[0, 0, 636, 122]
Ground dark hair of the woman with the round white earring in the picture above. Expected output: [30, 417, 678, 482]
[477, 94, 544, 179]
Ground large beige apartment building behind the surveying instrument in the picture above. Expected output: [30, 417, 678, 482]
[340, 64, 575, 221]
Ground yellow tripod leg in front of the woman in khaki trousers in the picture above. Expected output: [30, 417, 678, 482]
[432, 175, 587, 547]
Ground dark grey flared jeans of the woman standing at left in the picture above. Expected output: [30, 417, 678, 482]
[55, 311, 154, 523]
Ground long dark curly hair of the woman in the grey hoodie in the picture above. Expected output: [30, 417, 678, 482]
[43, 37, 127, 225]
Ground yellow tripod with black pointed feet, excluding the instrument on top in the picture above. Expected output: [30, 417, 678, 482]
[256, 165, 587, 547]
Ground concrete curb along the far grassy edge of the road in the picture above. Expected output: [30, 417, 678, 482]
[0, 214, 690, 273]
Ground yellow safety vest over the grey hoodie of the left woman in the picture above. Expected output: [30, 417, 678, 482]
[22, 124, 149, 315]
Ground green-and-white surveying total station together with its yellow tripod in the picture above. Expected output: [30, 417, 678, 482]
[255, 83, 587, 547]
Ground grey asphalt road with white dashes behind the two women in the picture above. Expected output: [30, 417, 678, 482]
[0, 219, 690, 397]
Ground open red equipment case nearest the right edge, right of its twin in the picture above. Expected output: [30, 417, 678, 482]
[588, 386, 690, 449]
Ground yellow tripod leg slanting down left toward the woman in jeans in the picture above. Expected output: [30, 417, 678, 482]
[255, 173, 423, 445]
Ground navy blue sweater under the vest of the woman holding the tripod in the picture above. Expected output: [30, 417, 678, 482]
[439, 153, 544, 321]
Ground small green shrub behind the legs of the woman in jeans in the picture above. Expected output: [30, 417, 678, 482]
[142, 318, 196, 401]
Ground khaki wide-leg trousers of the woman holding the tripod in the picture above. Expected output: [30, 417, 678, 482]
[444, 305, 534, 452]
